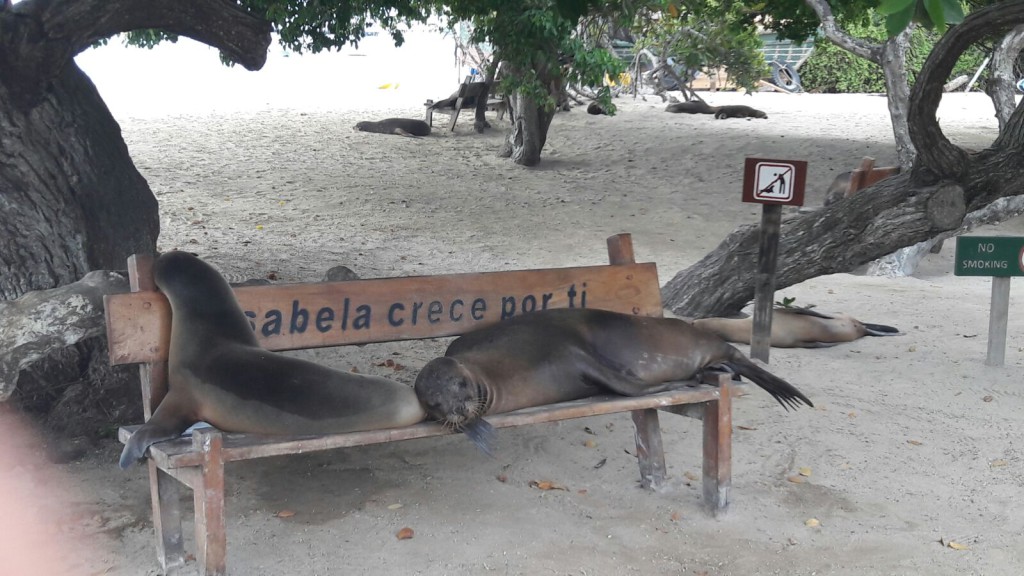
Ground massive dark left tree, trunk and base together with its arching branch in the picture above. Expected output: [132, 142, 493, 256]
[0, 0, 270, 429]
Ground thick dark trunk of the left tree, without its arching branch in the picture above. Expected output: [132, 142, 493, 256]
[0, 61, 160, 299]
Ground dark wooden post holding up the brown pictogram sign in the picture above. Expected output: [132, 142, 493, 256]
[751, 204, 782, 363]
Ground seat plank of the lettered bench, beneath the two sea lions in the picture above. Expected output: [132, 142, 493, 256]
[118, 382, 749, 469]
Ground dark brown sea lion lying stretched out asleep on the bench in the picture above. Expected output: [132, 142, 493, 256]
[414, 308, 813, 453]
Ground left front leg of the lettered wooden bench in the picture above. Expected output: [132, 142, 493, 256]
[193, 429, 227, 576]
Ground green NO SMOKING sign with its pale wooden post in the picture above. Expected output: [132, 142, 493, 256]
[953, 236, 1024, 366]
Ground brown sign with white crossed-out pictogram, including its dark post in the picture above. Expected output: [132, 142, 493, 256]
[743, 158, 807, 362]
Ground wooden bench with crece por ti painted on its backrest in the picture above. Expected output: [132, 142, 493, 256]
[104, 234, 749, 574]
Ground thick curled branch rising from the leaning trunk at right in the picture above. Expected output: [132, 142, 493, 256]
[907, 0, 1024, 179]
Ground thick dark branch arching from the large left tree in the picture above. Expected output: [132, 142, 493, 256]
[0, 0, 270, 108]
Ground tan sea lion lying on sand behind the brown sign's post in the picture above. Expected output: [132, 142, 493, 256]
[693, 308, 900, 348]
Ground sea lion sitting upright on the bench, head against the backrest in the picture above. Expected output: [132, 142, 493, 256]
[121, 252, 425, 468]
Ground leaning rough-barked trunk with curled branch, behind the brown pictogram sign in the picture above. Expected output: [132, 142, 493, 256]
[662, 0, 1024, 318]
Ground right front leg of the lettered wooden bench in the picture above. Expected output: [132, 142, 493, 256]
[702, 374, 732, 516]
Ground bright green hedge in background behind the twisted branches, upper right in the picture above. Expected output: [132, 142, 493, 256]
[800, 12, 985, 92]
